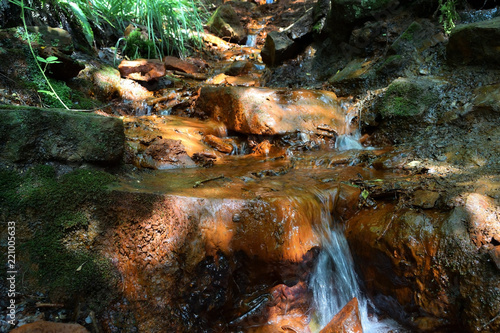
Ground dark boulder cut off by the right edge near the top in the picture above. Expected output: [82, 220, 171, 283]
[446, 17, 500, 67]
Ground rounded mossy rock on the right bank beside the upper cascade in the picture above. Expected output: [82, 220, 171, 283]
[380, 78, 439, 118]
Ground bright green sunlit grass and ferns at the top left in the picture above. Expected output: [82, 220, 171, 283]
[10, 0, 205, 56]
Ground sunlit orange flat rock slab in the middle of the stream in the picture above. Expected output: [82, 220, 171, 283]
[197, 87, 345, 135]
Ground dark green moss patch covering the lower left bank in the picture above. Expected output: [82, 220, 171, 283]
[0, 165, 116, 310]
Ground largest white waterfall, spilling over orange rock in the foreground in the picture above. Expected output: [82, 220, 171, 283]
[310, 191, 398, 333]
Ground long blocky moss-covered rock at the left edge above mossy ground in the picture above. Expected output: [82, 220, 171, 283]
[0, 108, 125, 164]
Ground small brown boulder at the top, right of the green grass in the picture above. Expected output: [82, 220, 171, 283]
[207, 4, 246, 43]
